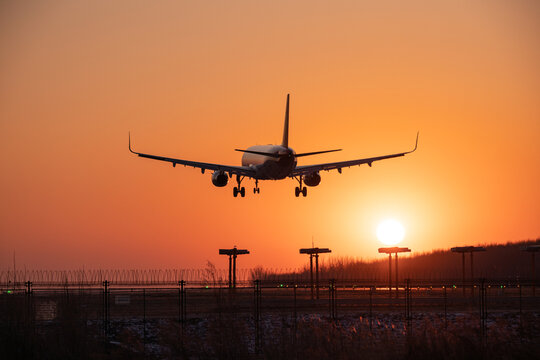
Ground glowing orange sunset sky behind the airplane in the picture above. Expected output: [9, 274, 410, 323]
[0, 0, 540, 269]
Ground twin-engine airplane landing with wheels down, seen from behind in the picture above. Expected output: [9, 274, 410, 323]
[128, 94, 418, 197]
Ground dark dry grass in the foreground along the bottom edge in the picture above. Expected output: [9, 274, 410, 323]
[0, 296, 540, 359]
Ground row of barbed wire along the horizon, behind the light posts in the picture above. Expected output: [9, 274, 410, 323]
[0, 267, 494, 287]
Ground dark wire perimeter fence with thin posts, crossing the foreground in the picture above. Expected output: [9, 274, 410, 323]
[0, 279, 540, 353]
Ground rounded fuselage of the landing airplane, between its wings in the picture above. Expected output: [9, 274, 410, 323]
[242, 145, 296, 180]
